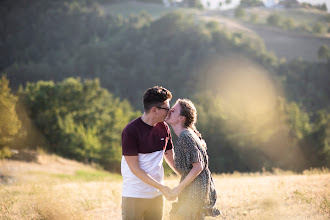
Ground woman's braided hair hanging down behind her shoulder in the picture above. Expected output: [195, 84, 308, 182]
[176, 99, 206, 148]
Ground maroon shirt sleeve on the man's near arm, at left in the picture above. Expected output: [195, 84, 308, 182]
[121, 127, 139, 156]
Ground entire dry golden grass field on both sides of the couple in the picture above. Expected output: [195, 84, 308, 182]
[0, 155, 330, 219]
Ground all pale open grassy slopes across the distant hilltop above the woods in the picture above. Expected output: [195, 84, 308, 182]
[104, 2, 330, 61]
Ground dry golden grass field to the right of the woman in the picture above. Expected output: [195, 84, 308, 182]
[214, 173, 330, 219]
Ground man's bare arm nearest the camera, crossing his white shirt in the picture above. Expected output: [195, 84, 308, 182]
[124, 156, 171, 198]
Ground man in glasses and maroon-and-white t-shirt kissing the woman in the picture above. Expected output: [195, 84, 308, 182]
[121, 86, 175, 220]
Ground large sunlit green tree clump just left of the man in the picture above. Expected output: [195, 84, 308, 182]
[20, 78, 141, 171]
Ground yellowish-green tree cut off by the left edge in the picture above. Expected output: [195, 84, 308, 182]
[0, 75, 21, 159]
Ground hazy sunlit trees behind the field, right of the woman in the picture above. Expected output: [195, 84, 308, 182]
[195, 93, 330, 172]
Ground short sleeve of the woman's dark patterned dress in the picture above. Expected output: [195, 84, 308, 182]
[182, 135, 203, 165]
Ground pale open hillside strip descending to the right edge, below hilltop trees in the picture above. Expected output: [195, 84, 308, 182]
[202, 11, 330, 62]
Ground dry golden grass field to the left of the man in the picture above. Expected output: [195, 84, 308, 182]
[0, 153, 121, 219]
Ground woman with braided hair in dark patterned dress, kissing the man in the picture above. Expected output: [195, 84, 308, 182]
[166, 99, 220, 220]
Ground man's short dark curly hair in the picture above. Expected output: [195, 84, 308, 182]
[143, 86, 172, 113]
